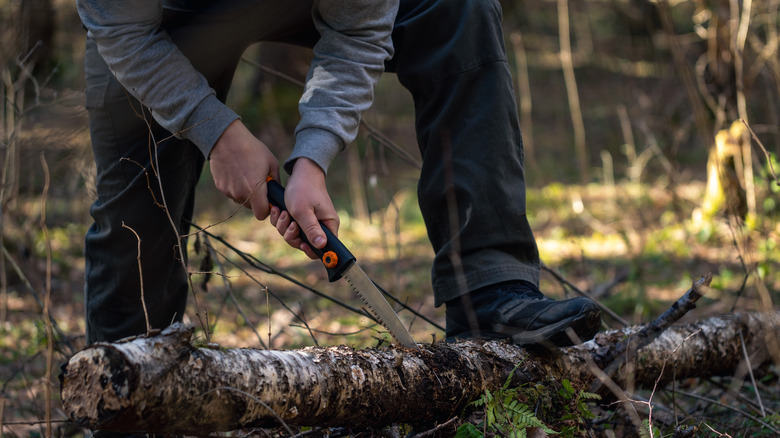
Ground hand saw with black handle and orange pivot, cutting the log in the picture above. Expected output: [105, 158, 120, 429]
[266, 176, 419, 349]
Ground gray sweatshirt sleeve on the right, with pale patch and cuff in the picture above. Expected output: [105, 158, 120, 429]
[284, 0, 398, 173]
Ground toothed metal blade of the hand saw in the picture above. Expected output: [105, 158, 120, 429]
[344, 263, 419, 350]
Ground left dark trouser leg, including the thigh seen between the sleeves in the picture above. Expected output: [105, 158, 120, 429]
[84, 0, 316, 343]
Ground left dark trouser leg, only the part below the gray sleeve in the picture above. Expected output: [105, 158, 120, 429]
[85, 36, 203, 342]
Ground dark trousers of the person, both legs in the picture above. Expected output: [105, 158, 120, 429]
[85, 0, 539, 342]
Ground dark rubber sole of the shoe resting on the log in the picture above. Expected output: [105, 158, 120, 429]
[447, 305, 601, 347]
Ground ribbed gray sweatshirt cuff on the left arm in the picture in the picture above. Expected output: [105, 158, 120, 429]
[181, 94, 240, 159]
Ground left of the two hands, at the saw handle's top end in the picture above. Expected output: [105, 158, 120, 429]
[209, 120, 279, 220]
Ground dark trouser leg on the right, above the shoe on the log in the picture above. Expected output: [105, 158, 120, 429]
[388, 0, 539, 305]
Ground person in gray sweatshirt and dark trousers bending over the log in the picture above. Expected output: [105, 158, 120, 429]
[77, 0, 600, 346]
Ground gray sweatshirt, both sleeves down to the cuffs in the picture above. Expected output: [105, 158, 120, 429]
[76, 0, 398, 172]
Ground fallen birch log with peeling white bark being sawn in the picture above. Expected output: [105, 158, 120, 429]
[61, 313, 780, 434]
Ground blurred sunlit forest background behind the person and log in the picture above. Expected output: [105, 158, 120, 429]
[0, 0, 780, 437]
